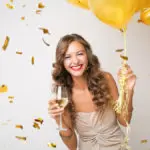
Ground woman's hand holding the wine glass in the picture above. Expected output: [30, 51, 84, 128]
[48, 100, 64, 121]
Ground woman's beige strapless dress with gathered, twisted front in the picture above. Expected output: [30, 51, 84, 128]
[75, 107, 125, 150]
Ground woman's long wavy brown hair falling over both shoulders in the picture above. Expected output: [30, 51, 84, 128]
[52, 34, 111, 125]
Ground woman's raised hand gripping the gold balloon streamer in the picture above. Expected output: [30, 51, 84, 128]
[118, 64, 136, 90]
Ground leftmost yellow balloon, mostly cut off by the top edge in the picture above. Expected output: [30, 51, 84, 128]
[67, 0, 89, 9]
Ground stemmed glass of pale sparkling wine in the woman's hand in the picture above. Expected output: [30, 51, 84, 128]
[56, 86, 68, 131]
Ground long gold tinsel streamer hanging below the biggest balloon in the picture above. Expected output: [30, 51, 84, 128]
[114, 28, 131, 150]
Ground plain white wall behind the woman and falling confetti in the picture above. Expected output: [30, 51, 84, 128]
[0, 0, 150, 150]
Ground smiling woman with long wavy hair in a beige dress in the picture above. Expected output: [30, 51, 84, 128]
[48, 34, 136, 150]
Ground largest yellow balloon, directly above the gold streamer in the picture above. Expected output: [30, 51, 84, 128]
[89, 0, 137, 29]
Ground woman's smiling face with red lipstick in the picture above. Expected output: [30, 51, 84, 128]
[64, 41, 88, 77]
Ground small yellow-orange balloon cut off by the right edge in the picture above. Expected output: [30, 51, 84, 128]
[138, 8, 150, 25]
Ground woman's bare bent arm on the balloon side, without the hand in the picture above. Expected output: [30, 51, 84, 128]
[106, 73, 133, 126]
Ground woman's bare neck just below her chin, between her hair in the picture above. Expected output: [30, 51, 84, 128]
[73, 77, 87, 90]
